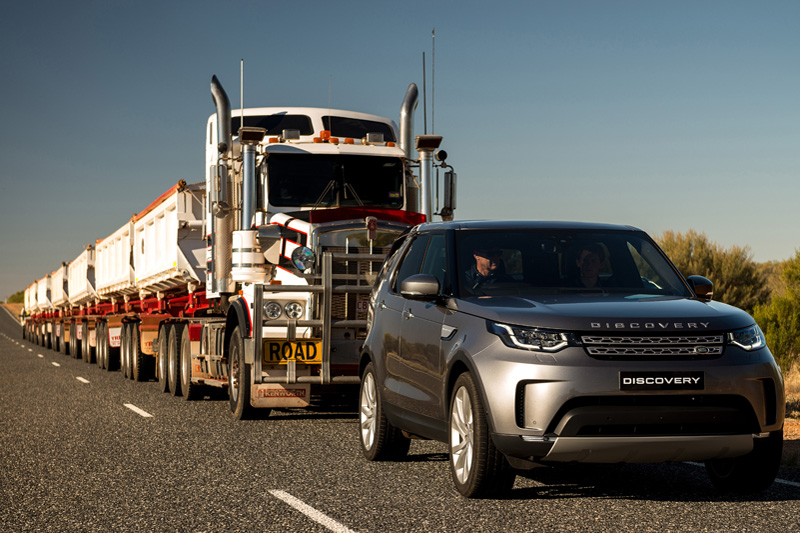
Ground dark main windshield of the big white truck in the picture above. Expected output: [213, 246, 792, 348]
[267, 154, 403, 209]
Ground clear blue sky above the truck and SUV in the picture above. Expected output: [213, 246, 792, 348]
[0, 0, 800, 298]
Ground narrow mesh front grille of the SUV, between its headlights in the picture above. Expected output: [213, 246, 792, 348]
[581, 335, 725, 361]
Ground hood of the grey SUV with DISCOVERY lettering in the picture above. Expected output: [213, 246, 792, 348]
[458, 294, 755, 333]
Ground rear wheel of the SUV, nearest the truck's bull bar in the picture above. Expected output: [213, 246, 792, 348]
[358, 363, 411, 461]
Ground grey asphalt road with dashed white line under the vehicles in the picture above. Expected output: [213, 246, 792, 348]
[0, 311, 800, 532]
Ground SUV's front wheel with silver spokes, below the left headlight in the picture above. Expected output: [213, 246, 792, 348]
[448, 372, 516, 498]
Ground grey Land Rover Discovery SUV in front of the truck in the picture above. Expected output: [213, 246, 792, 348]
[359, 221, 785, 497]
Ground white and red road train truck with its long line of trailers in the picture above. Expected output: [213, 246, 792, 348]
[23, 76, 456, 419]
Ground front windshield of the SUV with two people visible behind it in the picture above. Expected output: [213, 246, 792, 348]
[456, 229, 690, 297]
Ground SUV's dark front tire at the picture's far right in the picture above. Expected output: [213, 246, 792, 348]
[706, 429, 783, 494]
